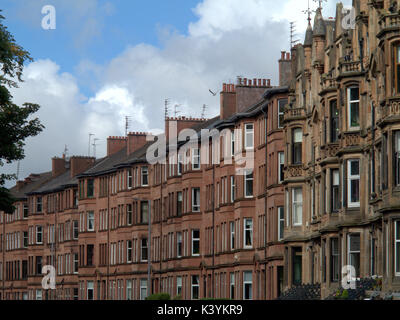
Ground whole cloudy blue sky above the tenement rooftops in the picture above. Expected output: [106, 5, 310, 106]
[0, 0, 351, 186]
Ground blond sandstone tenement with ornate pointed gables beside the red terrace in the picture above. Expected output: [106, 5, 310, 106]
[284, 0, 400, 297]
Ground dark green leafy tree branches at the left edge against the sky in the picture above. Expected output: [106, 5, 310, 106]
[0, 10, 44, 213]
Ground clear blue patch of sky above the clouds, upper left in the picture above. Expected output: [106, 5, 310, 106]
[1, 0, 199, 95]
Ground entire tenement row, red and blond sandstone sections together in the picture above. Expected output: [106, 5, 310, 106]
[0, 0, 400, 300]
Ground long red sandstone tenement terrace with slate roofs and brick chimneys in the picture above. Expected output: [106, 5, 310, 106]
[0, 52, 291, 300]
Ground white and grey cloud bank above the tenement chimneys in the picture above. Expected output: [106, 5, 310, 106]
[4, 0, 350, 186]
